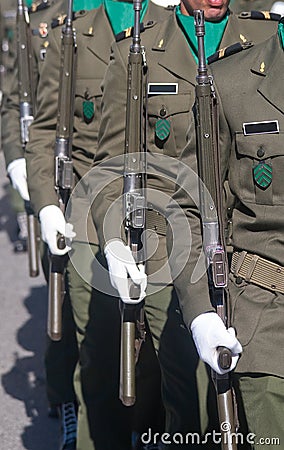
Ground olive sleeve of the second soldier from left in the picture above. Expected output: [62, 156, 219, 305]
[26, 29, 61, 213]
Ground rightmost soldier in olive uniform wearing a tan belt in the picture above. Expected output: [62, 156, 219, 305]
[169, 16, 284, 450]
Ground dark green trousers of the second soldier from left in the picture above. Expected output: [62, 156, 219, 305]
[67, 242, 163, 450]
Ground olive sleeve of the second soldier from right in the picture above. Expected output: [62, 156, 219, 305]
[88, 44, 127, 248]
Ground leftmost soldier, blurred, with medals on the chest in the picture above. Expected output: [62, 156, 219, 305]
[2, 0, 82, 449]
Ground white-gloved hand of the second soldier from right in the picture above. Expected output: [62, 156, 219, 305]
[105, 239, 147, 303]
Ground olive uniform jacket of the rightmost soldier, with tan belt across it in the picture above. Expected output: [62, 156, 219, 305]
[170, 35, 284, 377]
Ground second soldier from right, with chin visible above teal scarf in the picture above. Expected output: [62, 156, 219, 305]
[89, 1, 276, 448]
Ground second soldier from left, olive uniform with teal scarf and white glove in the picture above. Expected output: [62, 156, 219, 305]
[26, 1, 170, 450]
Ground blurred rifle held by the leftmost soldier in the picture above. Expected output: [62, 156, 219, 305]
[16, 0, 39, 277]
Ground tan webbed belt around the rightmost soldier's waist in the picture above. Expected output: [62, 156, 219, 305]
[231, 251, 284, 294]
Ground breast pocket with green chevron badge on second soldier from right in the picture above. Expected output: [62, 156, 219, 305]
[148, 92, 192, 157]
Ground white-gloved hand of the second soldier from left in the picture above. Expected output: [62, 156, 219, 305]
[39, 205, 76, 255]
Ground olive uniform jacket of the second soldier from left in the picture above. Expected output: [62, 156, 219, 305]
[26, 3, 169, 246]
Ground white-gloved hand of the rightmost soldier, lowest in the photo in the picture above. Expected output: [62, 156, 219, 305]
[190, 312, 242, 375]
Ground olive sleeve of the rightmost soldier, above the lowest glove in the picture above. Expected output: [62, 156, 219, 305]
[167, 89, 230, 328]
